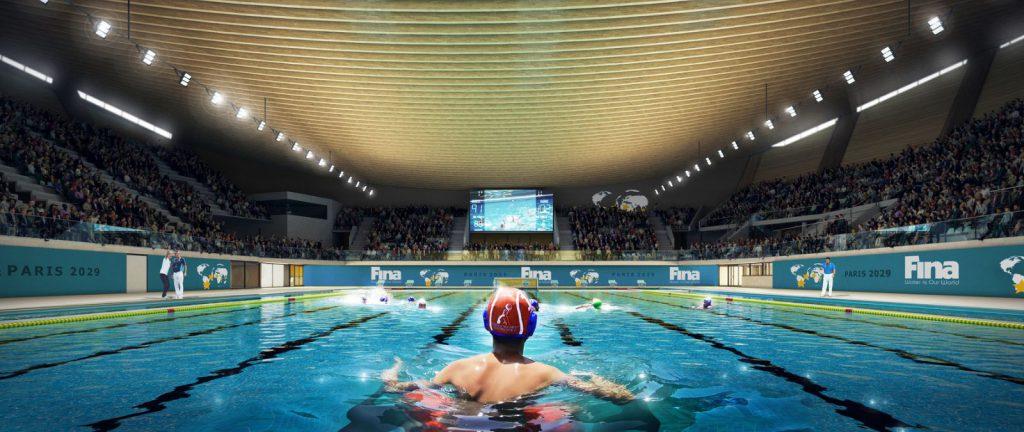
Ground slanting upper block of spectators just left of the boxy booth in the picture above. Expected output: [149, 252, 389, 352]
[155, 147, 269, 219]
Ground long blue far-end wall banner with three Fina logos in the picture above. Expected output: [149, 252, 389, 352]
[304, 264, 718, 288]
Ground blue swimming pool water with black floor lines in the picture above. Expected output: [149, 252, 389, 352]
[0, 291, 1024, 431]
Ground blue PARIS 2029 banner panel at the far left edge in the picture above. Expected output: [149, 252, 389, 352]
[0, 246, 126, 297]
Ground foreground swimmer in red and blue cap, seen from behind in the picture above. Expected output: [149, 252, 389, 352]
[381, 288, 634, 403]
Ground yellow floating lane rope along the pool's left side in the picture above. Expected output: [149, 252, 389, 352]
[0, 290, 360, 330]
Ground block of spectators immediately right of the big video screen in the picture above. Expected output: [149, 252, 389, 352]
[568, 206, 657, 259]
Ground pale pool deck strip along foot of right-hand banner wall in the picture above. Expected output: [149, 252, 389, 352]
[675, 287, 1024, 311]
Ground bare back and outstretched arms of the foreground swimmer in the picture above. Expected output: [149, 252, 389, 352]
[381, 353, 633, 403]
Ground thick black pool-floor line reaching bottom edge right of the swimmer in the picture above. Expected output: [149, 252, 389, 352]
[626, 311, 923, 431]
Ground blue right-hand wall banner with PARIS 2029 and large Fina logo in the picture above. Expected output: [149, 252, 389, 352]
[772, 246, 1024, 297]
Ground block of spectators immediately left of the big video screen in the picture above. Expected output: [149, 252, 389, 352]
[364, 207, 455, 260]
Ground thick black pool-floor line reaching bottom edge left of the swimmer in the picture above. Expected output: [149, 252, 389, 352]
[84, 312, 389, 431]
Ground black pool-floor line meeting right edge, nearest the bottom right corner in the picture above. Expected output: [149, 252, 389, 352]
[620, 296, 1024, 385]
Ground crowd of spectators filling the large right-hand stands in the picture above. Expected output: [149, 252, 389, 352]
[686, 99, 1024, 258]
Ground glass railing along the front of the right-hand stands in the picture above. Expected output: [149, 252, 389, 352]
[679, 211, 1024, 260]
